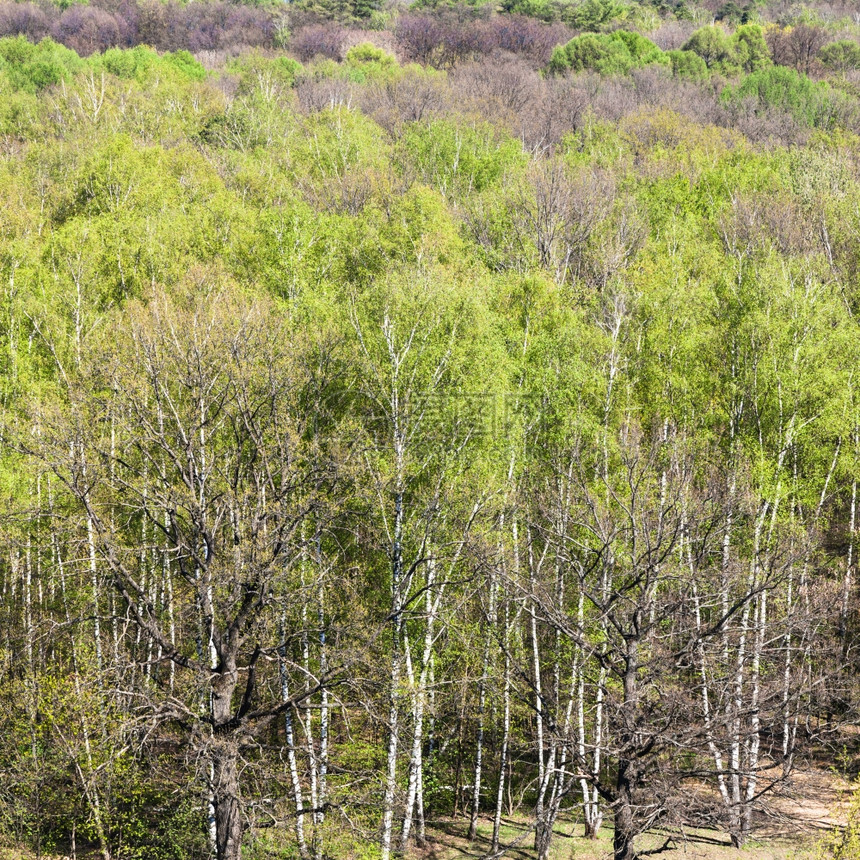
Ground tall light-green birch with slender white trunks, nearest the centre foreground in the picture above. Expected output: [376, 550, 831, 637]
[350, 271, 500, 859]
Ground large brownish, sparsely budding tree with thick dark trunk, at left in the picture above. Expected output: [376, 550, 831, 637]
[20, 291, 338, 860]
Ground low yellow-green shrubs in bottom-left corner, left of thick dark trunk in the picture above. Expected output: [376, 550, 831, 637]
[0, 672, 205, 860]
